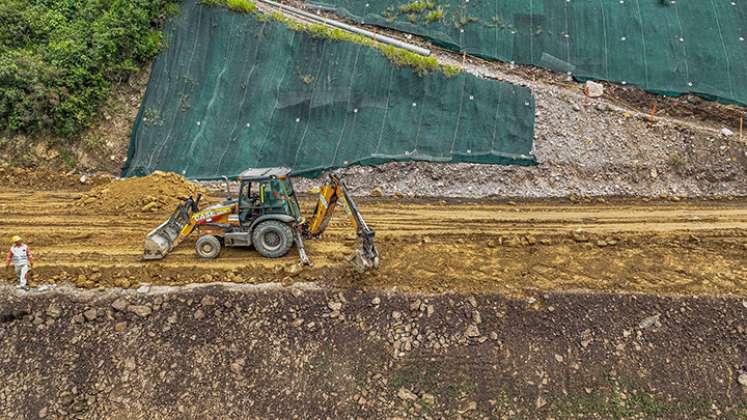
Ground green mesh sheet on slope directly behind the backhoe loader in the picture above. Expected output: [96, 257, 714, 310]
[123, 0, 535, 179]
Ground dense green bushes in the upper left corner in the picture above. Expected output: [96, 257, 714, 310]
[0, 0, 178, 136]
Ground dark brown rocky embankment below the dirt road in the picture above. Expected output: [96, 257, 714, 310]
[0, 285, 747, 419]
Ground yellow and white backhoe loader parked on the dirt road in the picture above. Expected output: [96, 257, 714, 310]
[143, 168, 379, 272]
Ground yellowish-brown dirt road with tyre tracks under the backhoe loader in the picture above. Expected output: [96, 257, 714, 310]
[0, 190, 747, 296]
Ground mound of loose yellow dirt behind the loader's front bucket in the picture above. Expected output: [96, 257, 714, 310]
[75, 171, 204, 213]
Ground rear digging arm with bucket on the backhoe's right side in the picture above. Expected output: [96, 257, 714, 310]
[302, 174, 379, 272]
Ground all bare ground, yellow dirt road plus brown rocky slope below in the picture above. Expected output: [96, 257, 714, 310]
[0, 180, 747, 419]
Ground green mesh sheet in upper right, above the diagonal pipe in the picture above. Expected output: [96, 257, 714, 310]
[307, 0, 747, 104]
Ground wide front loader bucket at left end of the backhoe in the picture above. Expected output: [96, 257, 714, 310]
[143, 195, 200, 260]
